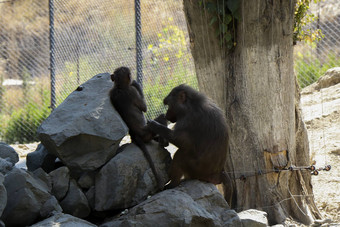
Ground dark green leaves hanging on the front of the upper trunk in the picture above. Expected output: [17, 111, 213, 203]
[199, 0, 241, 49]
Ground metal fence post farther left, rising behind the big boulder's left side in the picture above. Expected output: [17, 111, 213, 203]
[48, 0, 56, 111]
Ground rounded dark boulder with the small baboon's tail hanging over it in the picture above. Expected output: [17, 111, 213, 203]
[95, 141, 171, 211]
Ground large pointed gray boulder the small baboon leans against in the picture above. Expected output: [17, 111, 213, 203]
[38, 73, 128, 173]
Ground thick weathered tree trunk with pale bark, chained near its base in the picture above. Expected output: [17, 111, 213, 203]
[184, 0, 320, 224]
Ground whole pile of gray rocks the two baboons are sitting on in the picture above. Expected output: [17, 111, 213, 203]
[0, 74, 267, 227]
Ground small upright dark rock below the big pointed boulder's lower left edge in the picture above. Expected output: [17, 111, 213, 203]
[49, 166, 70, 201]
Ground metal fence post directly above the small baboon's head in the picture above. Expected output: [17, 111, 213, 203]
[135, 0, 143, 87]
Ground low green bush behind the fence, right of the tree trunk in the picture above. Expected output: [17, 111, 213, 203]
[294, 52, 340, 88]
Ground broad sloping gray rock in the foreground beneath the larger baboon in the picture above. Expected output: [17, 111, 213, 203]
[101, 181, 242, 227]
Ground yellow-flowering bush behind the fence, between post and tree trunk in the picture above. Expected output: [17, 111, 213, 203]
[144, 17, 198, 119]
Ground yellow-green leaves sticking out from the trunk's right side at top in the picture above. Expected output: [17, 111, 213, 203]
[293, 0, 323, 44]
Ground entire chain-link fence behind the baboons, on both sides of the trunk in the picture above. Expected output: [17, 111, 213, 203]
[0, 0, 340, 143]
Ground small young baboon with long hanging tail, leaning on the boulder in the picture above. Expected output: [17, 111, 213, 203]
[110, 67, 167, 190]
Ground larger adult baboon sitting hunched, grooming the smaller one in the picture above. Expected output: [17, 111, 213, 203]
[147, 84, 233, 202]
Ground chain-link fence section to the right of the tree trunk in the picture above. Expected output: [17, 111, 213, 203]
[294, 0, 340, 88]
